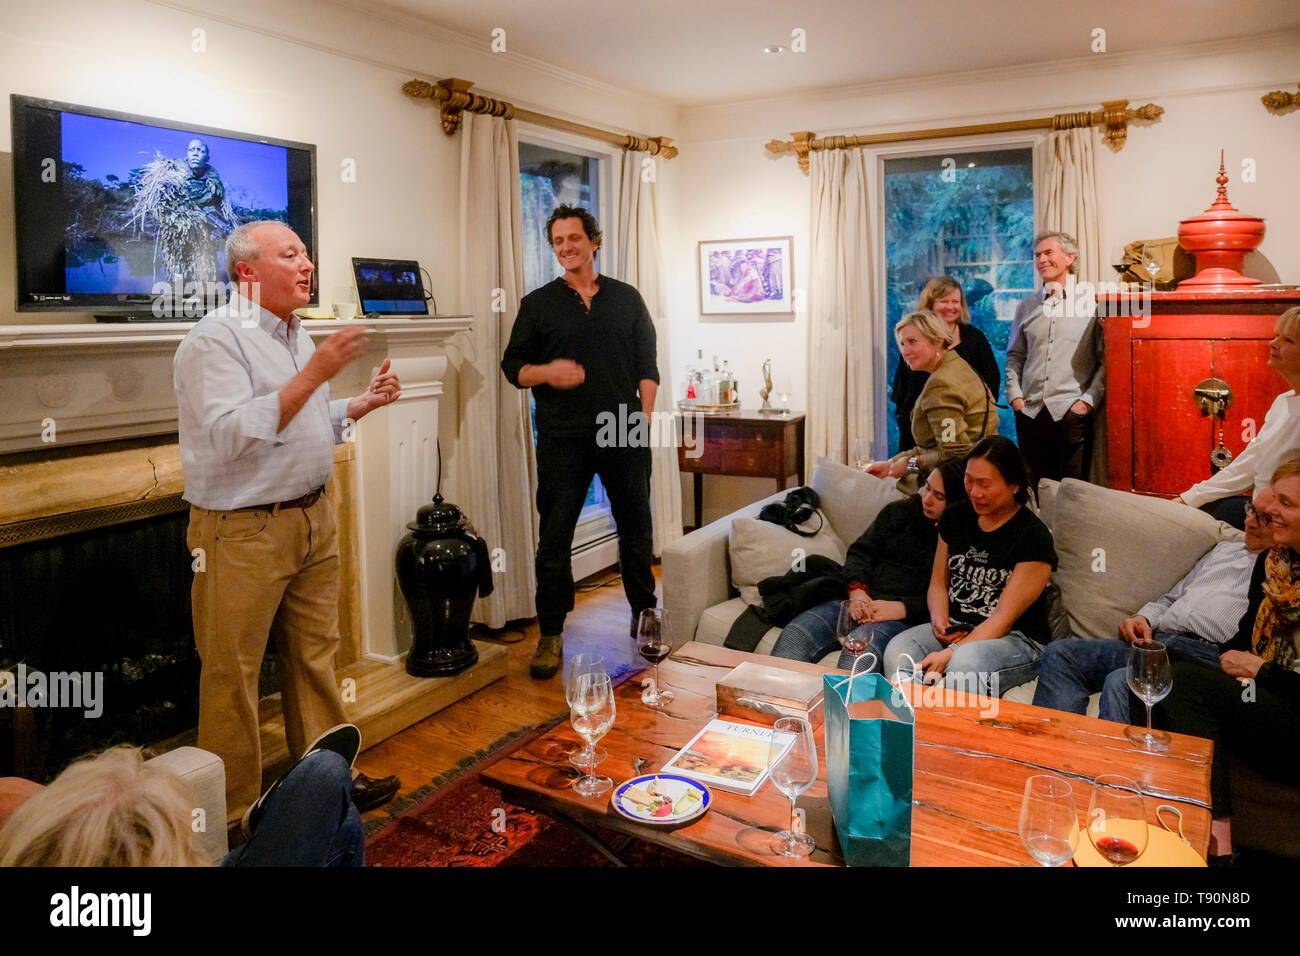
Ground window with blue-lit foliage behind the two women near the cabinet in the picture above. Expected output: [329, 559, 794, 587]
[878, 148, 1034, 453]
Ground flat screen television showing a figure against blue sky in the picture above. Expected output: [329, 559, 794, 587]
[9, 94, 319, 320]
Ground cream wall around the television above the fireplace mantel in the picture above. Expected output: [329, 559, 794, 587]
[0, 0, 680, 515]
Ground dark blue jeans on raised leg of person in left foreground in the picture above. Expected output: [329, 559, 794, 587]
[221, 750, 365, 866]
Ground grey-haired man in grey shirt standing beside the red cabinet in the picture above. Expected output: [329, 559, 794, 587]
[1006, 233, 1106, 484]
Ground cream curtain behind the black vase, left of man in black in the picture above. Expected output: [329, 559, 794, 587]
[449, 112, 537, 627]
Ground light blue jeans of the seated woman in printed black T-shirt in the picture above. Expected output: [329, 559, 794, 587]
[884, 623, 1043, 697]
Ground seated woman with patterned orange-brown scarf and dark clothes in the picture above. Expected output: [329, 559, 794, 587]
[1158, 458, 1300, 861]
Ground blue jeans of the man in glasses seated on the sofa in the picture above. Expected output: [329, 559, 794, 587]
[1034, 631, 1221, 723]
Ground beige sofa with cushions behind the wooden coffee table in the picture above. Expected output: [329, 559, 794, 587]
[663, 459, 1300, 858]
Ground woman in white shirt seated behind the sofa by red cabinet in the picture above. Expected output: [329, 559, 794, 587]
[1174, 306, 1300, 528]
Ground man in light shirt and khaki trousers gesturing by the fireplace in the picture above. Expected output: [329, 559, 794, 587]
[173, 221, 402, 822]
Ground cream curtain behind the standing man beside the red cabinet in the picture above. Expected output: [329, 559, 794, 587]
[1034, 126, 1113, 485]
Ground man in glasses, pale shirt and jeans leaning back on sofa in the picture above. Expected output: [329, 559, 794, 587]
[1034, 488, 1273, 723]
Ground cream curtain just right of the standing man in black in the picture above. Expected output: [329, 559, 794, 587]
[614, 150, 681, 555]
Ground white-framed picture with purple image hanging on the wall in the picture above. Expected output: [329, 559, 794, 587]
[699, 235, 794, 317]
